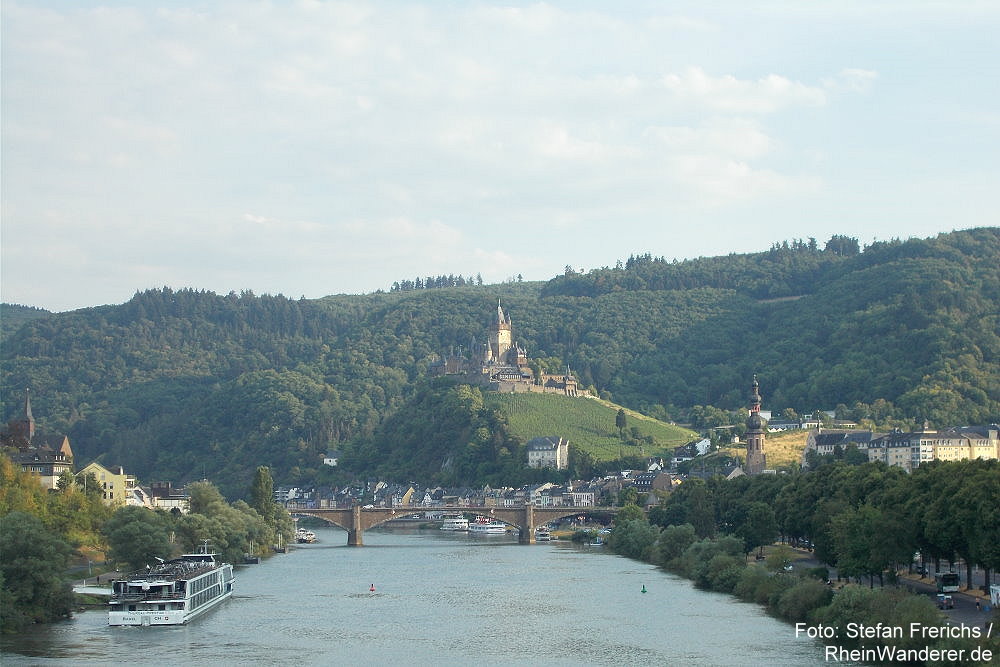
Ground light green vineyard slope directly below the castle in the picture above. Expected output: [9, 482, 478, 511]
[484, 394, 697, 461]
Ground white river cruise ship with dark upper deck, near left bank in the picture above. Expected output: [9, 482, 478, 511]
[108, 546, 235, 625]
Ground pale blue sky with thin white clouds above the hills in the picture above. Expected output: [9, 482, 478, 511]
[0, 0, 1000, 311]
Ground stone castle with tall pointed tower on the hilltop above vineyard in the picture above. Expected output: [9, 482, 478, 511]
[430, 299, 578, 396]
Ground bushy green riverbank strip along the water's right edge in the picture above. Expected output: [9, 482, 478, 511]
[608, 519, 1000, 665]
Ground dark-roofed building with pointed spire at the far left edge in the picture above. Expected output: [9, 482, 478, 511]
[0, 389, 73, 489]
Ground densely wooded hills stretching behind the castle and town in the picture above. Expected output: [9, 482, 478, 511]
[0, 228, 1000, 496]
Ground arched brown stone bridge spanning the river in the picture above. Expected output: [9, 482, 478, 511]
[290, 505, 618, 547]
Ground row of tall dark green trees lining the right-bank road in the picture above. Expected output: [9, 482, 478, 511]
[649, 459, 1000, 587]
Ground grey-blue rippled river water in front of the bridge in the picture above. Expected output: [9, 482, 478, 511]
[0, 528, 823, 666]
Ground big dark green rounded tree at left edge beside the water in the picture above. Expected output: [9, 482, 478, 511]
[0, 512, 73, 631]
